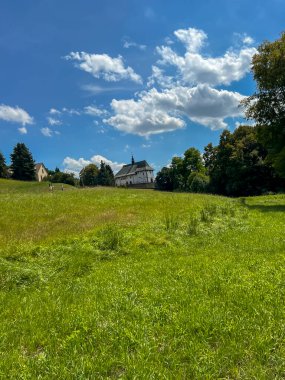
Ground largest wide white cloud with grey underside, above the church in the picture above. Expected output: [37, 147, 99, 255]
[104, 85, 243, 136]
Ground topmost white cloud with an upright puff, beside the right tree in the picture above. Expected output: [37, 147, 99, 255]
[154, 28, 257, 85]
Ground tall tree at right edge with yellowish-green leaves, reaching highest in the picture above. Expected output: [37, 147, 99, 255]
[243, 33, 285, 178]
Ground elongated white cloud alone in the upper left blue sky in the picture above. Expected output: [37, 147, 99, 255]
[65, 52, 142, 83]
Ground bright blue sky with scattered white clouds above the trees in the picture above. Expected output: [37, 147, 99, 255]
[0, 0, 285, 172]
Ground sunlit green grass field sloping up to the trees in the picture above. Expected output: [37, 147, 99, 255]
[0, 180, 285, 379]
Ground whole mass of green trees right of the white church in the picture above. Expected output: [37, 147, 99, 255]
[156, 33, 285, 196]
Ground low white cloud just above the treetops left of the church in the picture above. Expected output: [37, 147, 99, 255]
[63, 154, 125, 176]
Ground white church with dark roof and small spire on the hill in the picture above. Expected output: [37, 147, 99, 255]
[115, 157, 154, 189]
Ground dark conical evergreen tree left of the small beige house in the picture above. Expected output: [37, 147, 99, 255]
[11, 143, 36, 181]
